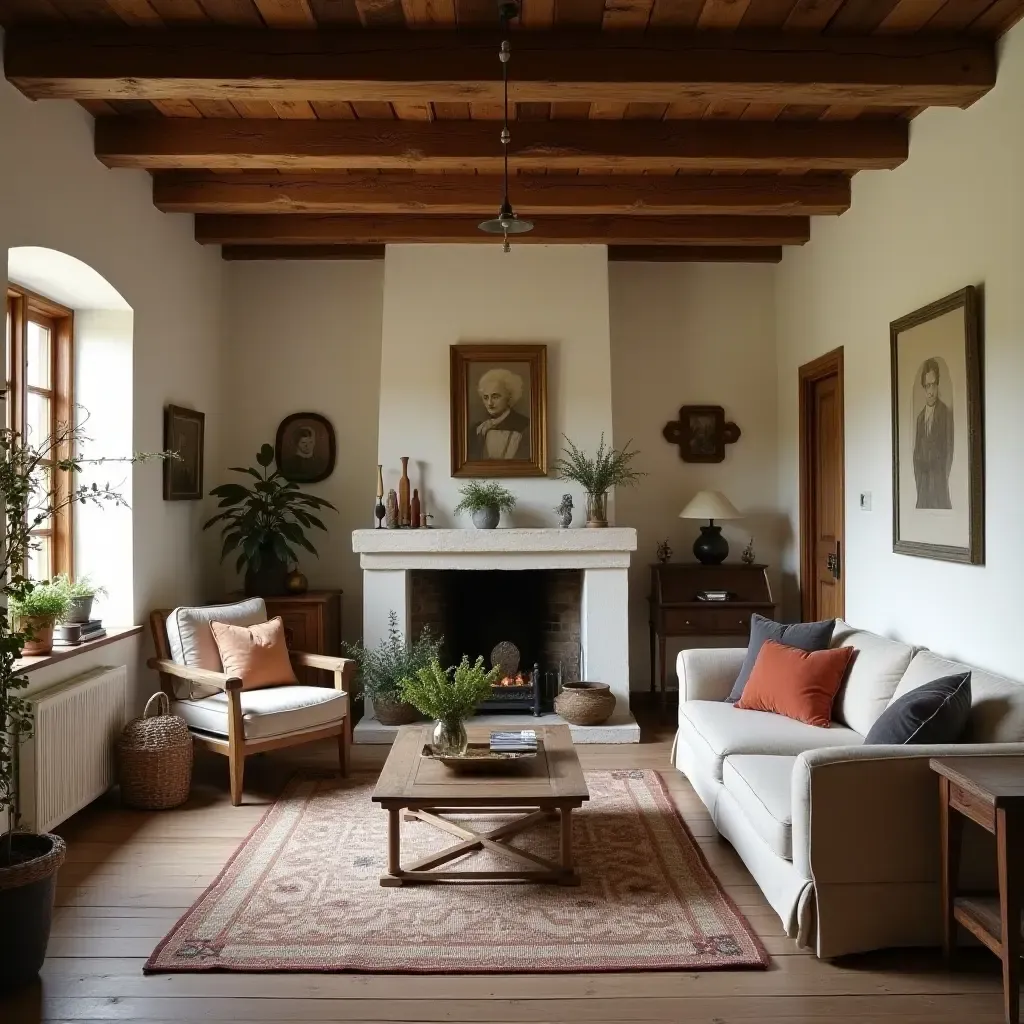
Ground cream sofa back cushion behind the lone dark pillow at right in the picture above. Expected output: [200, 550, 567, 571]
[893, 650, 1024, 743]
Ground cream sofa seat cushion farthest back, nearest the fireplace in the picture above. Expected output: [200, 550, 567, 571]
[679, 700, 864, 782]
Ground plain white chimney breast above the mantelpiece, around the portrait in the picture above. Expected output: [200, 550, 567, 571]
[378, 244, 612, 526]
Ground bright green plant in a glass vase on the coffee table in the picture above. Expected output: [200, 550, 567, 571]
[401, 654, 502, 755]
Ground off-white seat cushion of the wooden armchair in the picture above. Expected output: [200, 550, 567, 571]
[172, 686, 348, 739]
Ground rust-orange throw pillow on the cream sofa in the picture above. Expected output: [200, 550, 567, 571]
[736, 640, 854, 728]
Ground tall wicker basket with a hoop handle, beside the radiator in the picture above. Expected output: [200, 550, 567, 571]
[118, 692, 193, 811]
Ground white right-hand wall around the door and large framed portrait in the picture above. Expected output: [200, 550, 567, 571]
[777, 19, 1024, 677]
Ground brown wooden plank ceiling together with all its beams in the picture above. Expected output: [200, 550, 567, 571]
[0, 0, 1024, 262]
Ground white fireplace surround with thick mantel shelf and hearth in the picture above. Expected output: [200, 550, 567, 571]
[352, 526, 640, 743]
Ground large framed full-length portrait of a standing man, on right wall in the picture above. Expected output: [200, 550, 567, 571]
[889, 287, 985, 565]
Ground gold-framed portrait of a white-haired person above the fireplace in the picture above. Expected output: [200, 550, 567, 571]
[451, 345, 548, 476]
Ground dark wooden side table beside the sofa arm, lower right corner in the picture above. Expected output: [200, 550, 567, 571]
[929, 757, 1024, 1024]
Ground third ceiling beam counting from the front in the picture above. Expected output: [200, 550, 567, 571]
[153, 171, 850, 216]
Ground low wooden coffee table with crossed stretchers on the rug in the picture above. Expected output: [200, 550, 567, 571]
[373, 725, 590, 886]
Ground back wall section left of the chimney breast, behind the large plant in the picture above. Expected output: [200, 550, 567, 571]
[223, 260, 384, 640]
